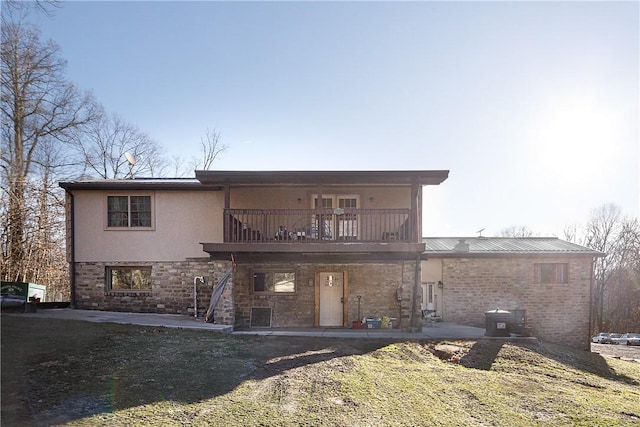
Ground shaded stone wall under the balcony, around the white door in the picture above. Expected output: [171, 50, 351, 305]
[235, 261, 421, 330]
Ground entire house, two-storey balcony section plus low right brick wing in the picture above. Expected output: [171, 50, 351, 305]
[60, 170, 599, 346]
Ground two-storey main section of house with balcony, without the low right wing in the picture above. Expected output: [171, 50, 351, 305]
[60, 170, 449, 330]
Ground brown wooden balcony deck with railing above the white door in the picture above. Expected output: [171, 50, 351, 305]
[203, 208, 424, 257]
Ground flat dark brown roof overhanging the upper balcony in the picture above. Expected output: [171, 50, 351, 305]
[196, 170, 449, 185]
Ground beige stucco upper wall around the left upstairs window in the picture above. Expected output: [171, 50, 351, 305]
[74, 191, 223, 262]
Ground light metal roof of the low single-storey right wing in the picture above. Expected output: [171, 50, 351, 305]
[422, 237, 605, 257]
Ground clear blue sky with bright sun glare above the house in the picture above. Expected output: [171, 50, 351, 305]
[31, 1, 640, 236]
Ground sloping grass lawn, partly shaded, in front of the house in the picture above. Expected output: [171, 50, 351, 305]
[1, 315, 640, 427]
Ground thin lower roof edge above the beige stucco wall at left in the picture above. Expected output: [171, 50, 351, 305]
[59, 178, 222, 190]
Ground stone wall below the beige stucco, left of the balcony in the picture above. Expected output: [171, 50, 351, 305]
[75, 258, 235, 325]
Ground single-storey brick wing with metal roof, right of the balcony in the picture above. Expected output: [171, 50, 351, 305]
[420, 237, 603, 350]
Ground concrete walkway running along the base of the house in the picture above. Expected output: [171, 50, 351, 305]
[2, 308, 492, 339]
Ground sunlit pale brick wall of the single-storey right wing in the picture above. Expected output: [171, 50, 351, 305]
[442, 257, 591, 350]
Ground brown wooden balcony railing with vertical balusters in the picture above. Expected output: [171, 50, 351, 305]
[224, 208, 414, 243]
